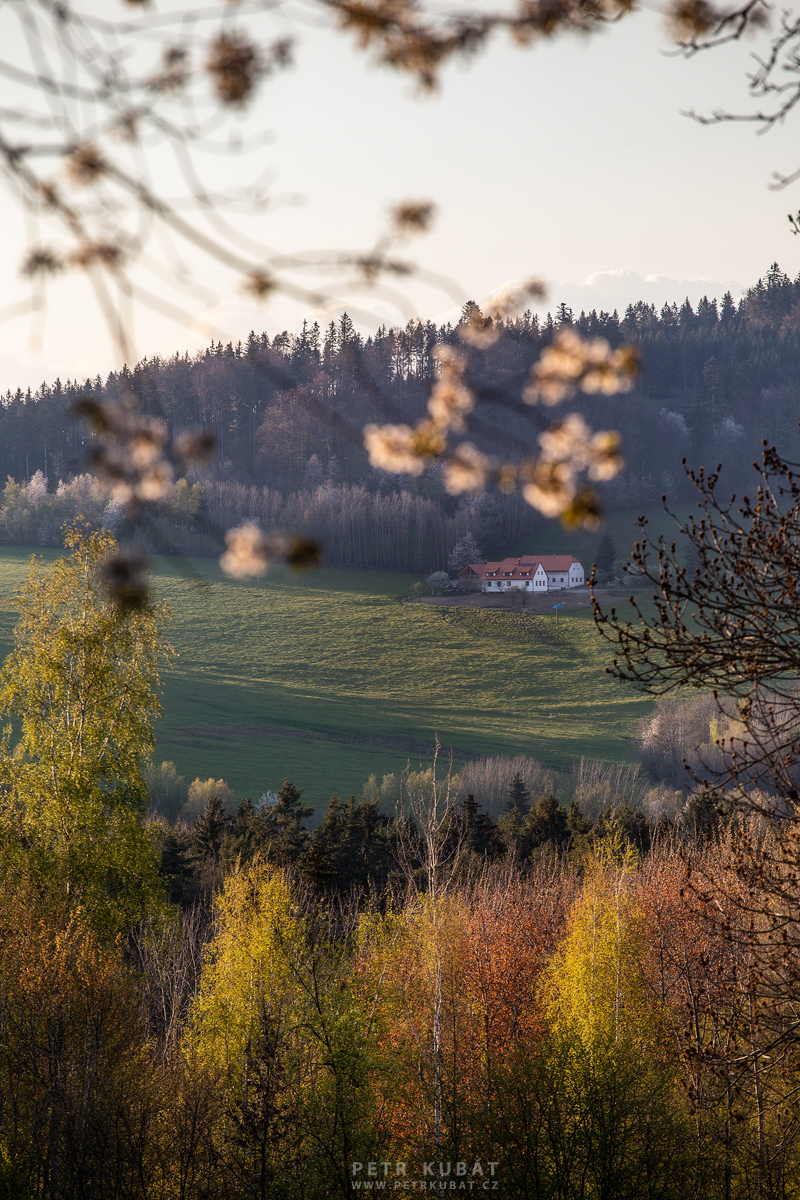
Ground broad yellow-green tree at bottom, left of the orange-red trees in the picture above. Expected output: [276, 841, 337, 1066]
[185, 859, 387, 1200]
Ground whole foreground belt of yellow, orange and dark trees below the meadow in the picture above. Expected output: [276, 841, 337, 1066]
[0, 535, 800, 1200]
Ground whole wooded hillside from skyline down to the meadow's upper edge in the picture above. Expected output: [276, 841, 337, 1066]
[0, 264, 800, 561]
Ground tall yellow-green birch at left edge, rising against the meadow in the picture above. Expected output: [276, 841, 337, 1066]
[0, 527, 169, 936]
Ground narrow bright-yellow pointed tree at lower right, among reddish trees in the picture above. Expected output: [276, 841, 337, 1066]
[546, 826, 688, 1200]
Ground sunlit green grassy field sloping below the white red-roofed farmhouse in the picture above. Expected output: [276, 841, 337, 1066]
[0, 535, 650, 804]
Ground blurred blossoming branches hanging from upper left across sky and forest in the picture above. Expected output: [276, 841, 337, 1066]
[0, 0, 637, 594]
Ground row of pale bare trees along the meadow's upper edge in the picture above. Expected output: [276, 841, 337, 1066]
[0, 472, 542, 575]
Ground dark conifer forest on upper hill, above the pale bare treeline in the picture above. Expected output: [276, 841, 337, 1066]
[0, 264, 800, 508]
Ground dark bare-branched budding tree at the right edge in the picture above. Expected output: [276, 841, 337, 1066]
[594, 444, 800, 1105]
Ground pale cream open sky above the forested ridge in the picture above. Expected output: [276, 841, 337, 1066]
[0, 1, 800, 392]
